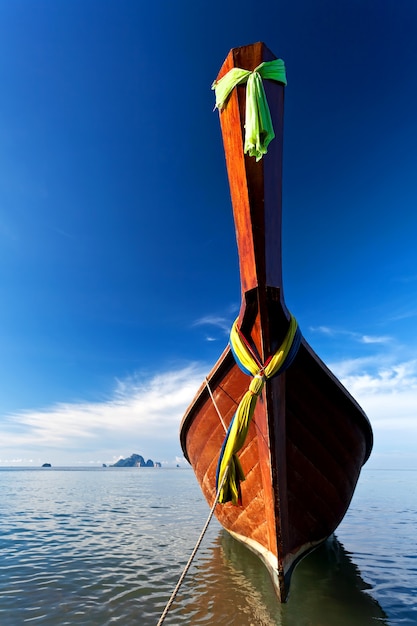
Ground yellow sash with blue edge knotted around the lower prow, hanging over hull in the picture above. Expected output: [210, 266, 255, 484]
[216, 315, 301, 504]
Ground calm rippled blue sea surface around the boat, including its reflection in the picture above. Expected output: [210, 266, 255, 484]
[0, 468, 417, 626]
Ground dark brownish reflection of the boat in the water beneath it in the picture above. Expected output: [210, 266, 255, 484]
[179, 531, 388, 626]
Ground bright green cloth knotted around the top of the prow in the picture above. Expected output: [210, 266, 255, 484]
[211, 59, 287, 161]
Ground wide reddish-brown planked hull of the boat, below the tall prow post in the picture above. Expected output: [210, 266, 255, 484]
[180, 334, 372, 601]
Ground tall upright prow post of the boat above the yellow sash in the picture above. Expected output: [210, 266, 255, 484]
[217, 43, 288, 361]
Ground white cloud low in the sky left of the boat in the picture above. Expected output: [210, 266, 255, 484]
[0, 365, 206, 463]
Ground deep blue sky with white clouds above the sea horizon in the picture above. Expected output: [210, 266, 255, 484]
[0, 0, 417, 467]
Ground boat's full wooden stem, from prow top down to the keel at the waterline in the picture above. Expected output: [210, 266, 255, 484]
[218, 43, 289, 598]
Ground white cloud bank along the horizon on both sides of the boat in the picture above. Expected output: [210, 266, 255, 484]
[0, 356, 417, 467]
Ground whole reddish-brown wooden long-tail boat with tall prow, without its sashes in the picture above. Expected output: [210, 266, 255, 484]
[180, 43, 372, 601]
